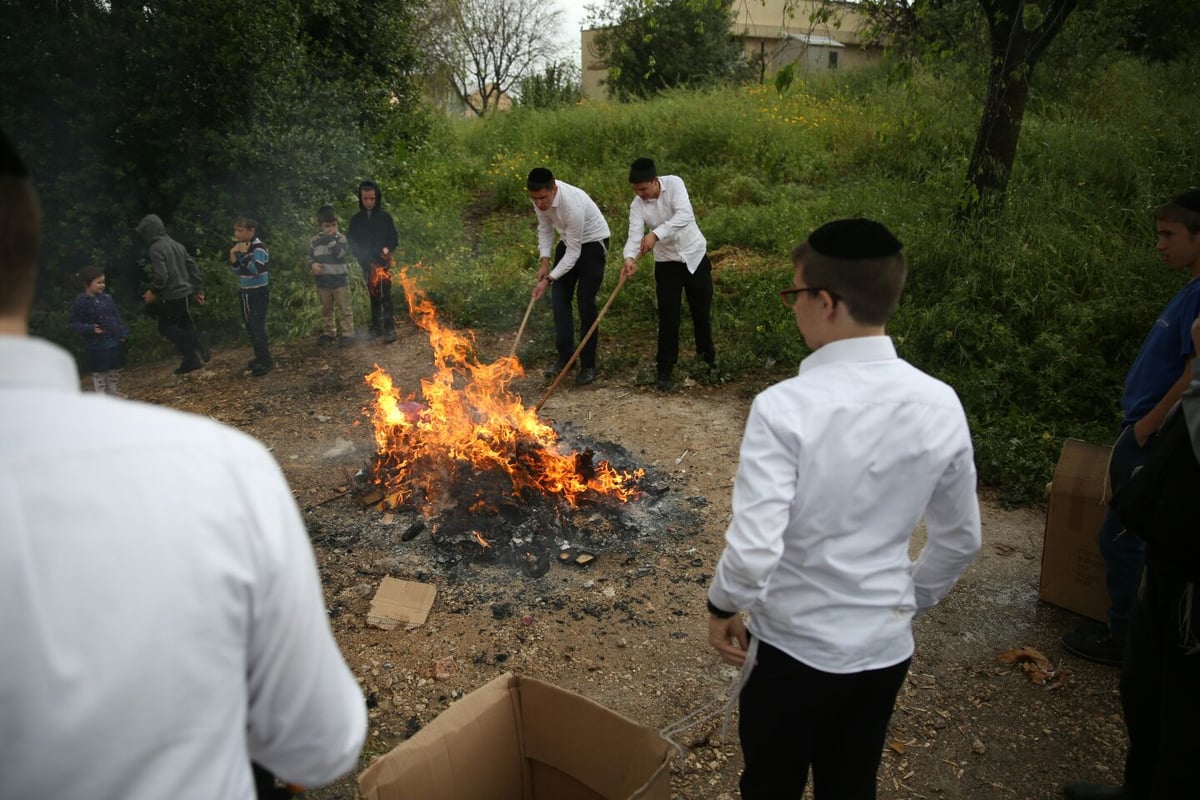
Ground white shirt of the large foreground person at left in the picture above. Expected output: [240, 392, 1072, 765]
[0, 335, 366, 800]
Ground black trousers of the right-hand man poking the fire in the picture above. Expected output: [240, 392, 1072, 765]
[654, 255, 716, 375]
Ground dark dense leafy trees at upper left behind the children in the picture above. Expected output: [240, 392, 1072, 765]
[0, 0, 422, 303]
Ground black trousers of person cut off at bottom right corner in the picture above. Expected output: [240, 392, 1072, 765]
[1121, 566, 1200, 800]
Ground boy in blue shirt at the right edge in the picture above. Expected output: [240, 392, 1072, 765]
[1062, 188, 1200, 666]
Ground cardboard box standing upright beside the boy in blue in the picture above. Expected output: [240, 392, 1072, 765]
[1038, 439, 1111, 622]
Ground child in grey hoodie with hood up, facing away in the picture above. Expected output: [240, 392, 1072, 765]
[137, 213, 210, 375]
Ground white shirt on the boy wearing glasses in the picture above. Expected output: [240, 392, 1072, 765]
[708, 336, 980, 673]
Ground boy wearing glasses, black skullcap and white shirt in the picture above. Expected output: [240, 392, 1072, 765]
[708, 219, 980, 800]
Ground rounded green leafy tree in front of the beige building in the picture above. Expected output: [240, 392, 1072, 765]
[593, 0, 746, 101]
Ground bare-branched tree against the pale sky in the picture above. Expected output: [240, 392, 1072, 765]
[428, 0, 563, 116]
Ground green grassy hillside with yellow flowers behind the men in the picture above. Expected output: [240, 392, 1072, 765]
[42, 60, 1200, 501]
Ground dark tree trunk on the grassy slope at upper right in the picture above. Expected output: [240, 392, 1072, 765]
[959, 0, 1078, 219]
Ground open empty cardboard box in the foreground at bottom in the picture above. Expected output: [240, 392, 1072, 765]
[359, 673, 671, 800]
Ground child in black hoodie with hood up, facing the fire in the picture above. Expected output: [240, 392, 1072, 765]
[348, 181, 400, 343]
